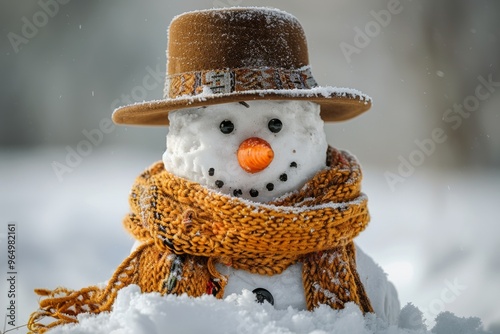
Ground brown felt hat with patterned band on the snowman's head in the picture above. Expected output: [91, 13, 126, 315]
[113, 7, 371, 125]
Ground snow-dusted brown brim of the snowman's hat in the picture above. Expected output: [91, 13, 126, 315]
[112, 87, 372, 125]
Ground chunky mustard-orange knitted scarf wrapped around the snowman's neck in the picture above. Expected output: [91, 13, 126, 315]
[28, 148, 373, 333]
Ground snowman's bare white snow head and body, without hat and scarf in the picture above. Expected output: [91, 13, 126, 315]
[163, 101, 399, 323]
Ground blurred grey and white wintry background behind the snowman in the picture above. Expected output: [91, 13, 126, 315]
[0, 0, 500, 332]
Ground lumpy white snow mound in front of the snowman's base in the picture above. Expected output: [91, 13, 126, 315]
[50, 285, 484, 334]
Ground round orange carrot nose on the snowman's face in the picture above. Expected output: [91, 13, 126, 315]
[238, 137, 274, 174]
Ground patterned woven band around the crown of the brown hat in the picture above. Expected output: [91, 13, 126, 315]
[164, 66, 318, 99]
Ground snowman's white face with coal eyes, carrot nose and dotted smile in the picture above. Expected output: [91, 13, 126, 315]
[163, 101, 327, 202]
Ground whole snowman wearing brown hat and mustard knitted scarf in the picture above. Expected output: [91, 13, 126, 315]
[30, 7, 399, 330]
